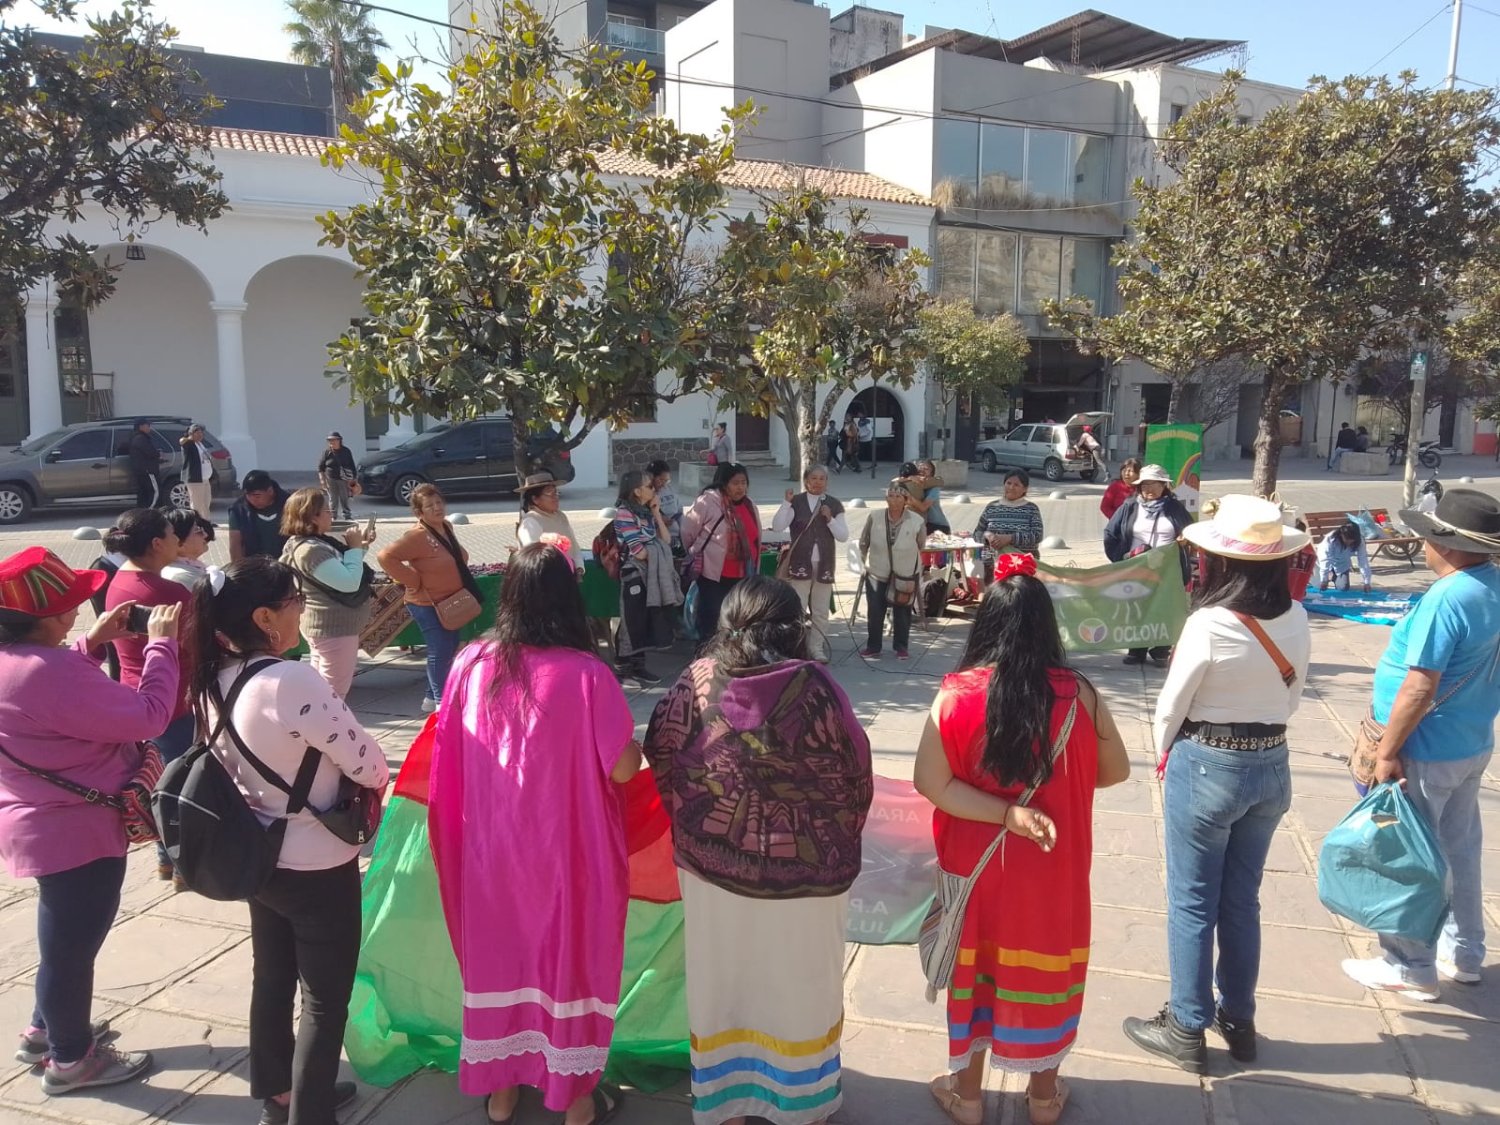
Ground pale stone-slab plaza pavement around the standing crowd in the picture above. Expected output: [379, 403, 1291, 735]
[0, 470, 1500, 1125]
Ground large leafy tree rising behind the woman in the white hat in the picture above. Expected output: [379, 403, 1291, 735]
[1049, 74, 1500, 495]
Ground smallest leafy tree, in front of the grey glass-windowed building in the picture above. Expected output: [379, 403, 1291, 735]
[917, 302, 1031, 459]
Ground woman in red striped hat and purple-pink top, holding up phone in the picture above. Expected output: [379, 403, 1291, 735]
[0, 548, 179, 1095]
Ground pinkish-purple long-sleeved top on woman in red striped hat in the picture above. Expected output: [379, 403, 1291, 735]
[0, 639, 179, 879]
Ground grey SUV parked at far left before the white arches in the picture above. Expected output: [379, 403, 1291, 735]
[0, 414, 236, 524]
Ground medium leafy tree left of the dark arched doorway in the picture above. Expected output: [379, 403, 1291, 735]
[713, 185, 927, 479]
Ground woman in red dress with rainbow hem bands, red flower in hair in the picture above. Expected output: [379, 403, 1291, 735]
[915, 555, 1130, 1125]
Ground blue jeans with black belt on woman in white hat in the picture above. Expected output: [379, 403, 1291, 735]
[1166, 738, 1292, 1031]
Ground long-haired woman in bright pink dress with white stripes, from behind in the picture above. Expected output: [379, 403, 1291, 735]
[428, 543, 641, 1125]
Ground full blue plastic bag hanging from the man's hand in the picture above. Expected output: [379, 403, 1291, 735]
[1317, 782, 1448, 944]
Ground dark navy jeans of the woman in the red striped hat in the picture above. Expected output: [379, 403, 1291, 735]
[32, 855, 125, 1062]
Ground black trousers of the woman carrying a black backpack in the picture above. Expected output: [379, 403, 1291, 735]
[251, 860, 360, 1125]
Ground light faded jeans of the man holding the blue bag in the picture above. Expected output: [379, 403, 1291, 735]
[1380, 752, 1490, 984]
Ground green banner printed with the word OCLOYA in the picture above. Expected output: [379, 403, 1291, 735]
[1037, 543, 1188, 653]
